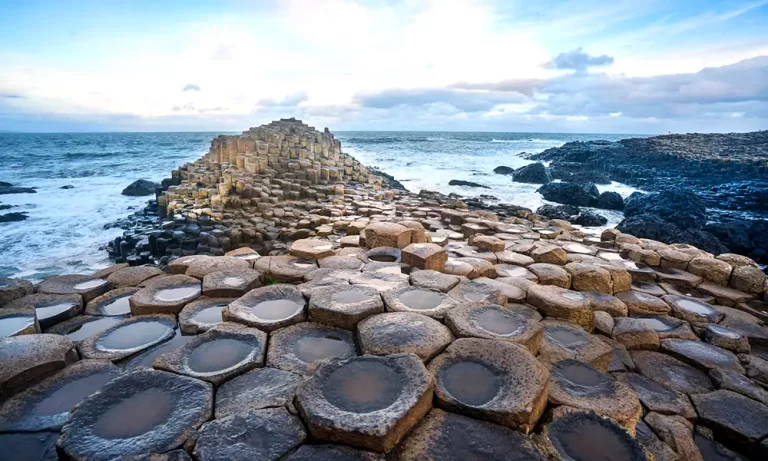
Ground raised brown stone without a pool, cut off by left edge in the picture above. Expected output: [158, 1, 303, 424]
[0, 334, 79, 401]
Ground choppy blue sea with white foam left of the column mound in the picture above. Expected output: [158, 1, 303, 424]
[0, 133, 218, 280]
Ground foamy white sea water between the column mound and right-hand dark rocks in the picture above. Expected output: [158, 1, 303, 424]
[336, 131, 637, 222]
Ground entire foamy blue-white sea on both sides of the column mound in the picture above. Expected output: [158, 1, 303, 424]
[0, 131, 635, 280]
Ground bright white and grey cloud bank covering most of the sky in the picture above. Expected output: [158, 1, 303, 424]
[0, 0, 768, 131]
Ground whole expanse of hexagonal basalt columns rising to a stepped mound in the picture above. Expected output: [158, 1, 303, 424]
[0, 120, 768, 461]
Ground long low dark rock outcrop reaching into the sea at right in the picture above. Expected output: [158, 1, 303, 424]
[528, 131, 768, 216]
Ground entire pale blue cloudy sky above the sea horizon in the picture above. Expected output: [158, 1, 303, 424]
[0, 0, 768, 134]
